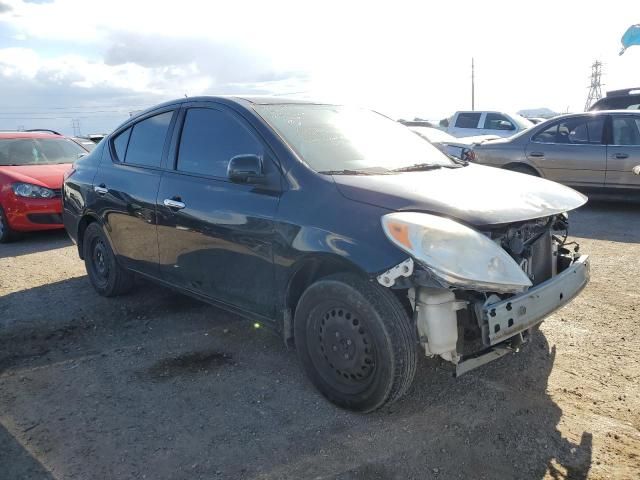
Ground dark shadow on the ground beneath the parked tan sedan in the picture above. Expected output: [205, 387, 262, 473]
[569, 200, 640, 243]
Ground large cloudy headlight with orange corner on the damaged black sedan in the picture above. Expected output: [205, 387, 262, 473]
[382, 212, 532, 292]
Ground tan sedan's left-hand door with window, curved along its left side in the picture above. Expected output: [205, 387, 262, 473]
[526, 115, 607, 188]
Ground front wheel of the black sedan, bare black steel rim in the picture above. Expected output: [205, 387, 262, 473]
[294, 274, 417, 412]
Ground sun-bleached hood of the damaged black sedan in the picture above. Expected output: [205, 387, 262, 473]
[333, 165, 587, 226]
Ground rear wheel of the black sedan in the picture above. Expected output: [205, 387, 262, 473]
[82, 223, 134, 297]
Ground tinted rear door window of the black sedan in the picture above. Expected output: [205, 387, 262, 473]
[120, 111, 174, 167]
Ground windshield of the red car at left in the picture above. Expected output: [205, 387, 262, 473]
[0, 138, 87, 165]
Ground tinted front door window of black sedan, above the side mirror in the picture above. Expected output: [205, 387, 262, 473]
[177, 108, 264, 178]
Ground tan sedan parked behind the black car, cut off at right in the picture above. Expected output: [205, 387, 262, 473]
[474, 110, 640, 195]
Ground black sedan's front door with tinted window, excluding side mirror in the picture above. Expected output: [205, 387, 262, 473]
[157, 103, 281, 316]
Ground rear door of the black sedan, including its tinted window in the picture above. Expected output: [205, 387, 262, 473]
[93, 108, 176, 276]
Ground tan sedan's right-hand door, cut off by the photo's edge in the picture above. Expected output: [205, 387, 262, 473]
[605, 113, 640, 189]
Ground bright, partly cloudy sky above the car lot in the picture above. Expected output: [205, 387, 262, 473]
[0, 0, 640, 134]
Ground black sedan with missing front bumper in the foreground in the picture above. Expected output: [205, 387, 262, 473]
[63, 97, 589, 411]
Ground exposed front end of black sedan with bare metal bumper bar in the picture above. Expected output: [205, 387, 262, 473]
[378, 214, 588, 374]
